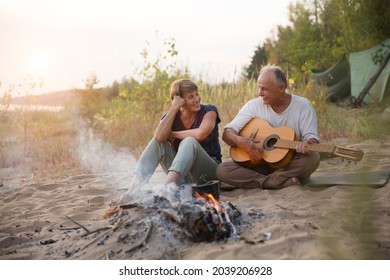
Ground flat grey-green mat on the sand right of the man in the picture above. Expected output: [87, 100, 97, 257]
[305, 170, 390, 188]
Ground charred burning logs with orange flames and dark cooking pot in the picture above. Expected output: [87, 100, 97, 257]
[116, 181, 241, 242]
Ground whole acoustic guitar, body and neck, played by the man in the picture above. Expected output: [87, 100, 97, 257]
[230, 118, 363, 169]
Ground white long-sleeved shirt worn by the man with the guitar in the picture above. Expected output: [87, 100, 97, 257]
[225, 94, 319, 141]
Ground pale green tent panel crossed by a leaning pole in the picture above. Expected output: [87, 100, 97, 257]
[349, 39, 390, 103]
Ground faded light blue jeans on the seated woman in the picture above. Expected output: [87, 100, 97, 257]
[134, 137, 219, 184]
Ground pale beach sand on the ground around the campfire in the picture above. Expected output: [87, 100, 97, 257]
[0, 137, 390, 260]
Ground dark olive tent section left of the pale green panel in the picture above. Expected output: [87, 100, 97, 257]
[312, 55, 351, 102]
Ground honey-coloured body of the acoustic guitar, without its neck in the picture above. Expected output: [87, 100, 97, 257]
[230, 118, 297, 169]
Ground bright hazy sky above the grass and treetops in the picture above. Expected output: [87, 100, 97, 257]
[0, 0, 292, 96]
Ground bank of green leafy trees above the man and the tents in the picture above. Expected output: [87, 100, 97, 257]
[253, 0, 390, 87]
